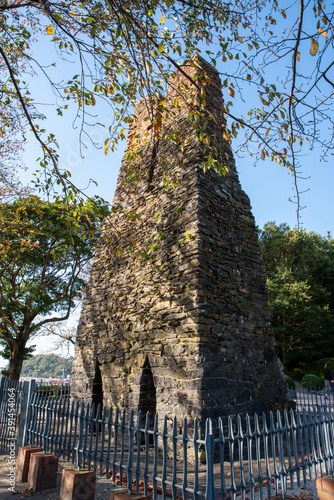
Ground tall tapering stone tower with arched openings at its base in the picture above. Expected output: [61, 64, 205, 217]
[72, 58, 286, 419]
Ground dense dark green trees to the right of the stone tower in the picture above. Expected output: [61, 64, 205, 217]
[260, 222, 334, 369]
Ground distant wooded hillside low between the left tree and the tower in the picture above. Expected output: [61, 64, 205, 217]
[21, 354, 73, 378]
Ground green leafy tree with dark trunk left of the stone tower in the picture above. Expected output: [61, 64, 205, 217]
[0, 196, 106, 379]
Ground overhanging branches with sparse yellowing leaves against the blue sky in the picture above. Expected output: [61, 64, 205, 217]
[0, 0, 334, 219]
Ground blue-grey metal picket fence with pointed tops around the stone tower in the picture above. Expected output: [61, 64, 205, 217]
[0, 380, 334, 500]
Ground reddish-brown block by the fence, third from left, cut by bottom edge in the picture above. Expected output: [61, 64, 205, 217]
[59, 467, 96, 500]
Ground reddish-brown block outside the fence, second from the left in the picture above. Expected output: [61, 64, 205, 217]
[28, 453, 58, 493]
